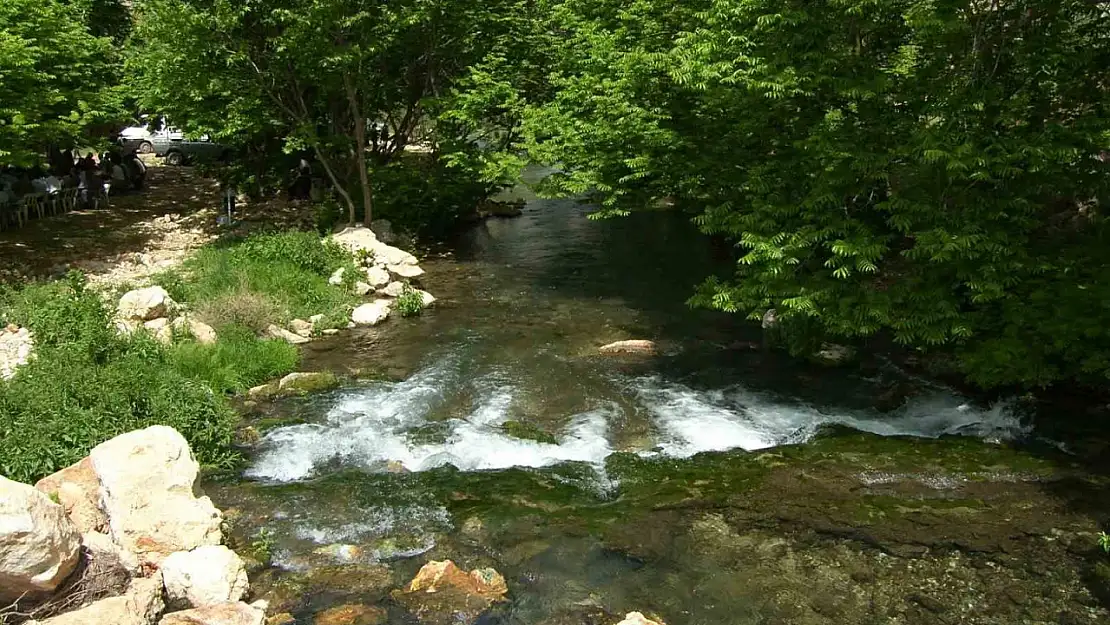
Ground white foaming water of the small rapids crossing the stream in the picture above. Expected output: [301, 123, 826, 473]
[246, 360, 1025, 482]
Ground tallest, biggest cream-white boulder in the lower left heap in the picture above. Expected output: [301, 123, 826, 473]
[89, 425, 222, 564]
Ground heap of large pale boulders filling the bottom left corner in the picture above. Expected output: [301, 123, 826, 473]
[0, 425, 257, 625]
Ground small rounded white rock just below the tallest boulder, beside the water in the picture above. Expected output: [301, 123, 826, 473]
[162, 545, 250, 608]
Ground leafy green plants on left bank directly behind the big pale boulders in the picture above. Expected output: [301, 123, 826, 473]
[0, 274, 239, 482]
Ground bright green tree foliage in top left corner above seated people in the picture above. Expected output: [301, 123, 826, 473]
[0, 0, 115, 165]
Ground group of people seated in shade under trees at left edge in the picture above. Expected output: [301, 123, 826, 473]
[0, 145, 147, 226]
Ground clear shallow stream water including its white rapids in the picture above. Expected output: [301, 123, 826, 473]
[209, 184, 1107, 625]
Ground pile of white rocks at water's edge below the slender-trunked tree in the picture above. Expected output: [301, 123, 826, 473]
[329, 224, 435, 325]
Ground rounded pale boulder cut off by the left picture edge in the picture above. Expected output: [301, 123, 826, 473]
[0, 476, 81, 605]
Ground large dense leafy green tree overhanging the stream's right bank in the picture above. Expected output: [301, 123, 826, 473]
[527, 0, 1110, 385]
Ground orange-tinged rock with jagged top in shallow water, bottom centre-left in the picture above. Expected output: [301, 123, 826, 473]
[393, 560, 508, 625]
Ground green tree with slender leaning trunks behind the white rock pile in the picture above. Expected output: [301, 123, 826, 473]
[130, 0, 541, 221]
